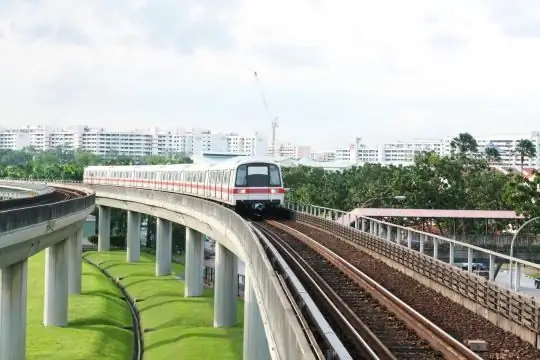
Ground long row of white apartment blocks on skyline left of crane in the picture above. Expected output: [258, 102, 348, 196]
[0, 126, 267, 157]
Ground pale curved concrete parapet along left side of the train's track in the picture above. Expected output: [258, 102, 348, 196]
[10, 180, 315, 360]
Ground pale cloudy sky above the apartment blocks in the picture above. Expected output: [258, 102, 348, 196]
[0, 0, 540, 148]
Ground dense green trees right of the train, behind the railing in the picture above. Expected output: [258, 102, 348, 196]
[283, 133, 540, 233]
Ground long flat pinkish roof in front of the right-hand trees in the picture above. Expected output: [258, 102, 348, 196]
[342, 208, 524, 219]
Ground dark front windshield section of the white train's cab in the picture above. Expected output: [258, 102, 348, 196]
[236, 163, 281, 187]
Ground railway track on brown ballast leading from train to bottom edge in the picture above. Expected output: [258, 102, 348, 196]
[257, 221, 482, 360]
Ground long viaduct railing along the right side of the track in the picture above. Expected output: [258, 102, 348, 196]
[294, 204, 540, 347]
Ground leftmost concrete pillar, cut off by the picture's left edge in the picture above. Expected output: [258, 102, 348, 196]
[0, 260, 28, 360]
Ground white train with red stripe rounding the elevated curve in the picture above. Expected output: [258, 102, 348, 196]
[83, 156, 286, 217]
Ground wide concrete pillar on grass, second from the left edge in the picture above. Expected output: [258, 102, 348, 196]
[43, 240, 69, 326]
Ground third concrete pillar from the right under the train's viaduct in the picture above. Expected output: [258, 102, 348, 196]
[184, 227, 204, 297]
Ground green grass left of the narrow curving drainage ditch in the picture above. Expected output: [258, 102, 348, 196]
[26, 252, 133, 360]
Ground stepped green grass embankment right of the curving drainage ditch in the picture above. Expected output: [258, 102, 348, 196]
[86, 251, 244, 360]
